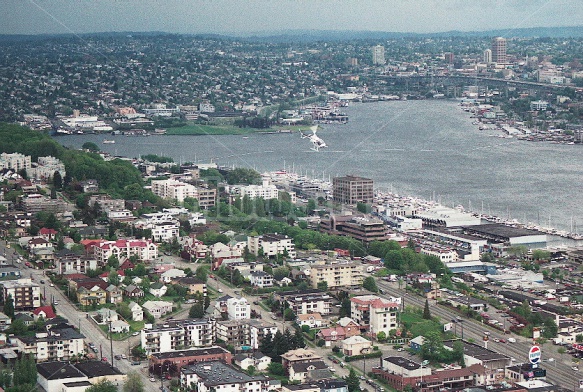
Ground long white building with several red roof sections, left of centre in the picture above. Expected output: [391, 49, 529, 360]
[93, 240, 158, 265]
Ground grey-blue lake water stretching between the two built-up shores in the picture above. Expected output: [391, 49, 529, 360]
[57, 100, 583, 237]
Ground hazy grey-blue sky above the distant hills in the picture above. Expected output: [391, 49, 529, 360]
[0, 0, 583, 35]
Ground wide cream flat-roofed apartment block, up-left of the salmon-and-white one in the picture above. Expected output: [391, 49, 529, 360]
[308, 262, 364, 289]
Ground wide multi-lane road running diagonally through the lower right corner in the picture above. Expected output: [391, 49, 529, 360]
[379, 281, 583, 389]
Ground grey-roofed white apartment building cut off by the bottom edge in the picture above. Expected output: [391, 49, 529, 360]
[180, 361, 269, 392]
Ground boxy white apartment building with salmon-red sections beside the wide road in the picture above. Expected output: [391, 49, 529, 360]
[350, 295, 399, 335]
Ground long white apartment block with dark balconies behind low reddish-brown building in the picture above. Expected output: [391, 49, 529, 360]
[141, 319, 215, 355]
